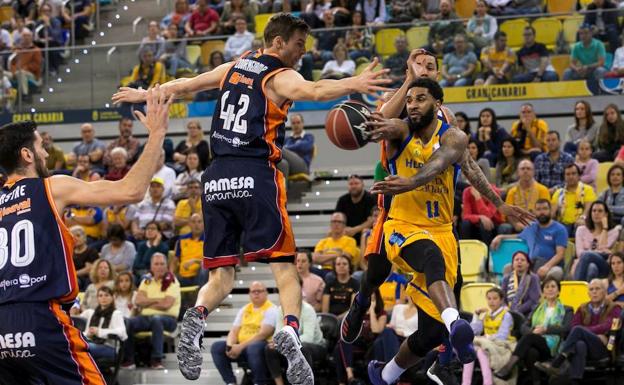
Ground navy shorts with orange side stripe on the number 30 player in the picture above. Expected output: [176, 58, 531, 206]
[0, 302, 106, 385]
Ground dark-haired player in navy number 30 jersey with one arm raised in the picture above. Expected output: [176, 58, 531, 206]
[0, 89, 171, 385]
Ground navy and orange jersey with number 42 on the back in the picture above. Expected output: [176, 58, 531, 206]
[210, 50, 292, 162]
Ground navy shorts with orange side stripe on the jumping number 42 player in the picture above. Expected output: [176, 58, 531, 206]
[202, 157, 295, 269]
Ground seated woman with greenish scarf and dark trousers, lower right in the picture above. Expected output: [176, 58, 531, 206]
[494, 277, 572, 384]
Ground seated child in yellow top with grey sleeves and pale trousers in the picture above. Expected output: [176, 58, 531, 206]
[462, 287, 516, 385]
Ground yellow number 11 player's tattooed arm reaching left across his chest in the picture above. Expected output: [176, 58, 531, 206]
[371, 127, 468, 195]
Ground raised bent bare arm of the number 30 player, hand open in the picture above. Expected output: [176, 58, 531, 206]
[50, 86, 174, 211]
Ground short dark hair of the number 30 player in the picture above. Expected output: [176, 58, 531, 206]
[0, 120, 37, 174]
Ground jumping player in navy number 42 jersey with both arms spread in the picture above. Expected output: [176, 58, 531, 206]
[113, 13, 390, 384]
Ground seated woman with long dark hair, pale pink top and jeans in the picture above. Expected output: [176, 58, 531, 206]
[574, 201, 622, 282]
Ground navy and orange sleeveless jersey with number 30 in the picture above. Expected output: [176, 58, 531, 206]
[0, 178, 78, 305]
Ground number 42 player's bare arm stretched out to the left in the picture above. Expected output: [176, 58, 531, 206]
[112, 63, 232, 104]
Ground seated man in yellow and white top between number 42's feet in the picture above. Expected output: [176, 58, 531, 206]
[210, 281, 277, 384]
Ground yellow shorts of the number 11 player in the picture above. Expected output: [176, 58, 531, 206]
[384, 219, 458, 322]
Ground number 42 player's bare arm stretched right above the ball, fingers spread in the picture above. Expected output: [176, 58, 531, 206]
[272, 59, 392, 101]
